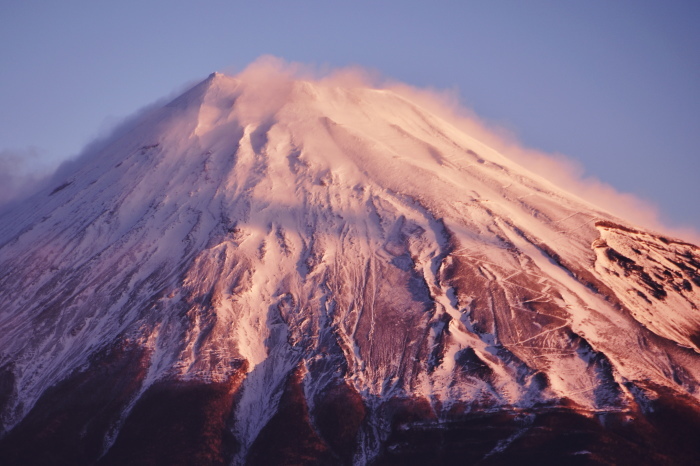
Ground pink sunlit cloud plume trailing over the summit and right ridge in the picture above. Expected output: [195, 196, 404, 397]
[223, 56, 700, 243]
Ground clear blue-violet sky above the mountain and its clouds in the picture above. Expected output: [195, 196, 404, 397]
[0, 0, 700, 237]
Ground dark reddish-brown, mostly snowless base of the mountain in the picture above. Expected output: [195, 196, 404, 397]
[0, 361, 700, 465]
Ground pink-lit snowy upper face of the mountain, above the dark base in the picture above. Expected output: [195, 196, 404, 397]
[0, 74, 700, 461]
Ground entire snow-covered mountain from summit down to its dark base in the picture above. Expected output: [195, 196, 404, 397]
[0, 74, 700, 464]
